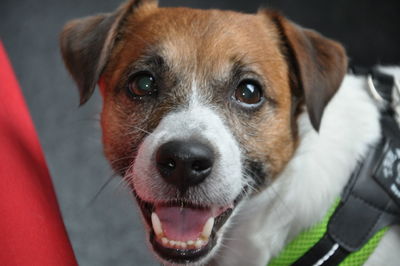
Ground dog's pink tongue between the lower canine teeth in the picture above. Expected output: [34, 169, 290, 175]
[155, 206, 212, 242]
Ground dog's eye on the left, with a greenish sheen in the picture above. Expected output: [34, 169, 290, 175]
[128, 73, 156, 98]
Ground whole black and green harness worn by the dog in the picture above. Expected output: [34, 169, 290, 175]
[268, 68, 400, 266]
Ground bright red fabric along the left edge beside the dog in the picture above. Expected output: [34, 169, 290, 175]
[0, 42, 77, 266]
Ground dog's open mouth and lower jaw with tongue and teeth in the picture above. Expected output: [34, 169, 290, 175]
[135, 192, 244, 265]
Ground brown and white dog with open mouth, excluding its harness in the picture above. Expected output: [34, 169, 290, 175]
[60, 0, 400, 265]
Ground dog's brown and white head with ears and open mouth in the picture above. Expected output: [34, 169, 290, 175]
[61, 0, 346, 263]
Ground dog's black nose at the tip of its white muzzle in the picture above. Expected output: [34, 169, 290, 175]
[156, 140, 214, 192]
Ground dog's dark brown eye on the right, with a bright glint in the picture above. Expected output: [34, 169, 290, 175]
[234, 80, 262, 105]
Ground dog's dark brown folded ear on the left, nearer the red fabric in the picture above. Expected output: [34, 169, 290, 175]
[60, 0, 157, 105]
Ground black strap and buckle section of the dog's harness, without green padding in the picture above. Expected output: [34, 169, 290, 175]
[292, 69, 400, 266]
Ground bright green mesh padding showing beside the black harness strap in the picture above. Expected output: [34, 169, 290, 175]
[268, 200, 388, 266]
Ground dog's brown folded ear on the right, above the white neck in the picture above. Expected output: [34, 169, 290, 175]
[264, 11, 347, 131]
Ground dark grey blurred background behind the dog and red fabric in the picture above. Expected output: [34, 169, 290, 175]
[0, 0, 400, 266]
